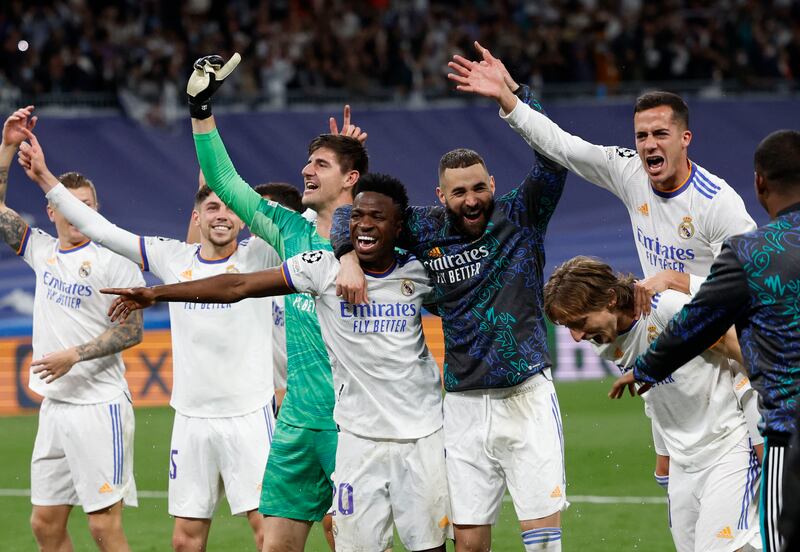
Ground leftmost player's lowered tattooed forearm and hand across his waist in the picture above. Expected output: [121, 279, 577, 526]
[31, 312, 143, 383]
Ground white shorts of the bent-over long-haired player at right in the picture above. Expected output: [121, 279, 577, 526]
[668, 437, 761, 552]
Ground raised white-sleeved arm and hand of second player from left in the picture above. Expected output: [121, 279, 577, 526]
[19, 131, 142, 265]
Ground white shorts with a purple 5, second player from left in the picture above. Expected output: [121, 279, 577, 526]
[169, 404, 275, 519]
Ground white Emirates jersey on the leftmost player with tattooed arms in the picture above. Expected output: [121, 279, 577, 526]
[19, 228, 144, 404]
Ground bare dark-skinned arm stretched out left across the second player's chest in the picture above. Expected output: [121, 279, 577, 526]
[100, 267, 294, 321]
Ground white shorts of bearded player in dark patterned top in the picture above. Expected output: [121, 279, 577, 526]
[444, 369, 568, 525]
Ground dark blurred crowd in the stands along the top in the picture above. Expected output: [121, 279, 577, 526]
[0, 0, 800, 120]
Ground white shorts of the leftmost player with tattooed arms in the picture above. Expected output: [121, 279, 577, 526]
[31, 394, 138, 513]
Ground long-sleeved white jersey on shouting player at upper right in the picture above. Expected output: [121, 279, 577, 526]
[501, 102, 756, 292]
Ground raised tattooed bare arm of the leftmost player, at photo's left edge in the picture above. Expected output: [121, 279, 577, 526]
[0, 105, 36, 253]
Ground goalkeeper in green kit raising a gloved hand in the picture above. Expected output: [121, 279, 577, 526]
[186, 54, 368, 552]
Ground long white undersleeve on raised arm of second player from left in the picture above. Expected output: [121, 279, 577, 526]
[47, 184, 142, 264]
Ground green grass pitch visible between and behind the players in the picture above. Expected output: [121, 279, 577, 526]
[0, 380, 674, 552]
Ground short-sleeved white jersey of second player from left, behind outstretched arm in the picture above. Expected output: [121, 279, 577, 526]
[140, 237, 280, 418]
